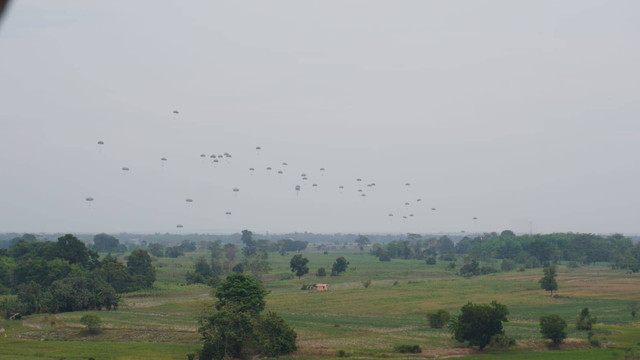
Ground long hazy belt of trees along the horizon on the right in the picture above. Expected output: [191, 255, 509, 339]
[370, 230, 640, 272]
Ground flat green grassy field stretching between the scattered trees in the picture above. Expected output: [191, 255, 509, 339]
[0, 247, 640, 360]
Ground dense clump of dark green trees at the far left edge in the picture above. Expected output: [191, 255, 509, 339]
[0, 234, 155, 315]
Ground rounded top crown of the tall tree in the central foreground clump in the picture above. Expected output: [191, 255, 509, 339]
[216, 274, 268, 314]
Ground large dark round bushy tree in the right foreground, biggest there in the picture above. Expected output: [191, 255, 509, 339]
[449, 301, 509, 350]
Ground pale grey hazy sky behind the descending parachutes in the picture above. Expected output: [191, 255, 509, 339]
[0, 0, 640, 233]
